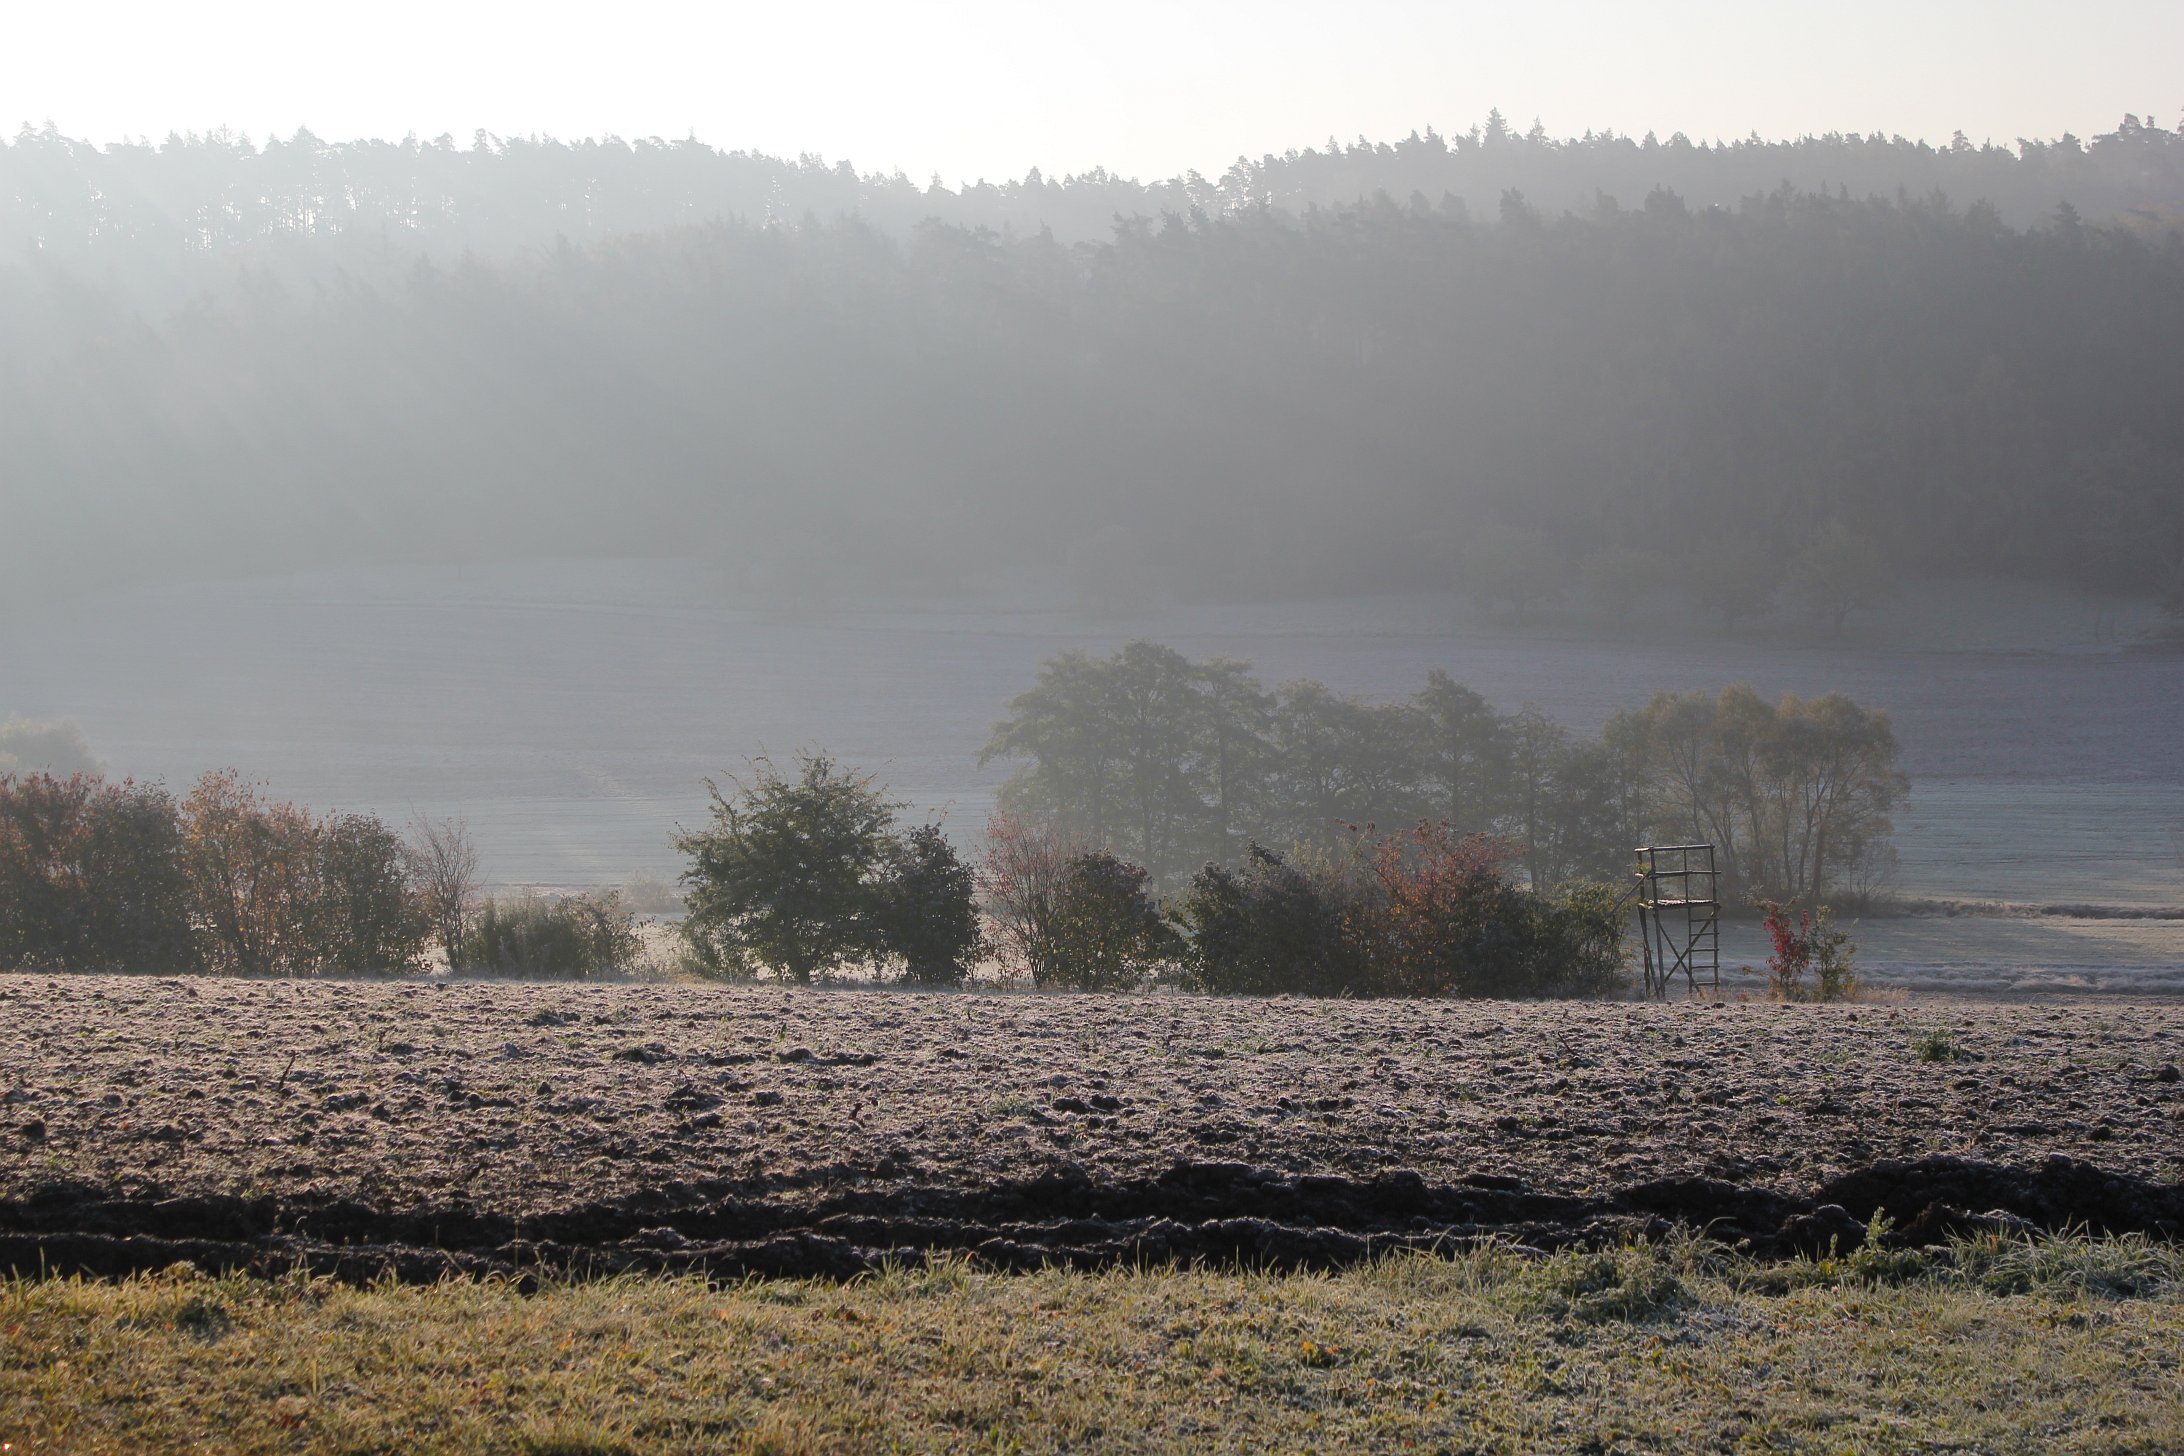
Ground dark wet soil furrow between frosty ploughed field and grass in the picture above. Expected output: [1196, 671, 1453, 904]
[0, 1157, 2184, 1279]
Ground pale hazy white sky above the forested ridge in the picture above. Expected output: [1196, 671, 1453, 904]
[0, 0, 2184, 181]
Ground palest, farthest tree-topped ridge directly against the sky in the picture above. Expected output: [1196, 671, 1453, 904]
[12, 111, 2184, 299]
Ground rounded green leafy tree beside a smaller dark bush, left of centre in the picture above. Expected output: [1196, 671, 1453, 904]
[675, 753, 900, 984]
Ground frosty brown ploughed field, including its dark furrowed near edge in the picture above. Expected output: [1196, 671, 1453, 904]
[0, 976, 2184, 1277]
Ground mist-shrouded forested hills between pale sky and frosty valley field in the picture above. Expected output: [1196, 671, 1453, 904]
[0, 114, 2184, 618]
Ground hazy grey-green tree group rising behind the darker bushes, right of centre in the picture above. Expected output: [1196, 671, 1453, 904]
[985, 642, 1909, 899]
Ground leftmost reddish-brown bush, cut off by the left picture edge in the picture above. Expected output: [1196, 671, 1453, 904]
[0, 773, 199, 971]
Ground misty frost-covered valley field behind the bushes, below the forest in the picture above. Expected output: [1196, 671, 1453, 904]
[0, 563, 2184, 967]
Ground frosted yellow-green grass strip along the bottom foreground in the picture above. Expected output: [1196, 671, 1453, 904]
[0, 1240, 2184, 1456]
